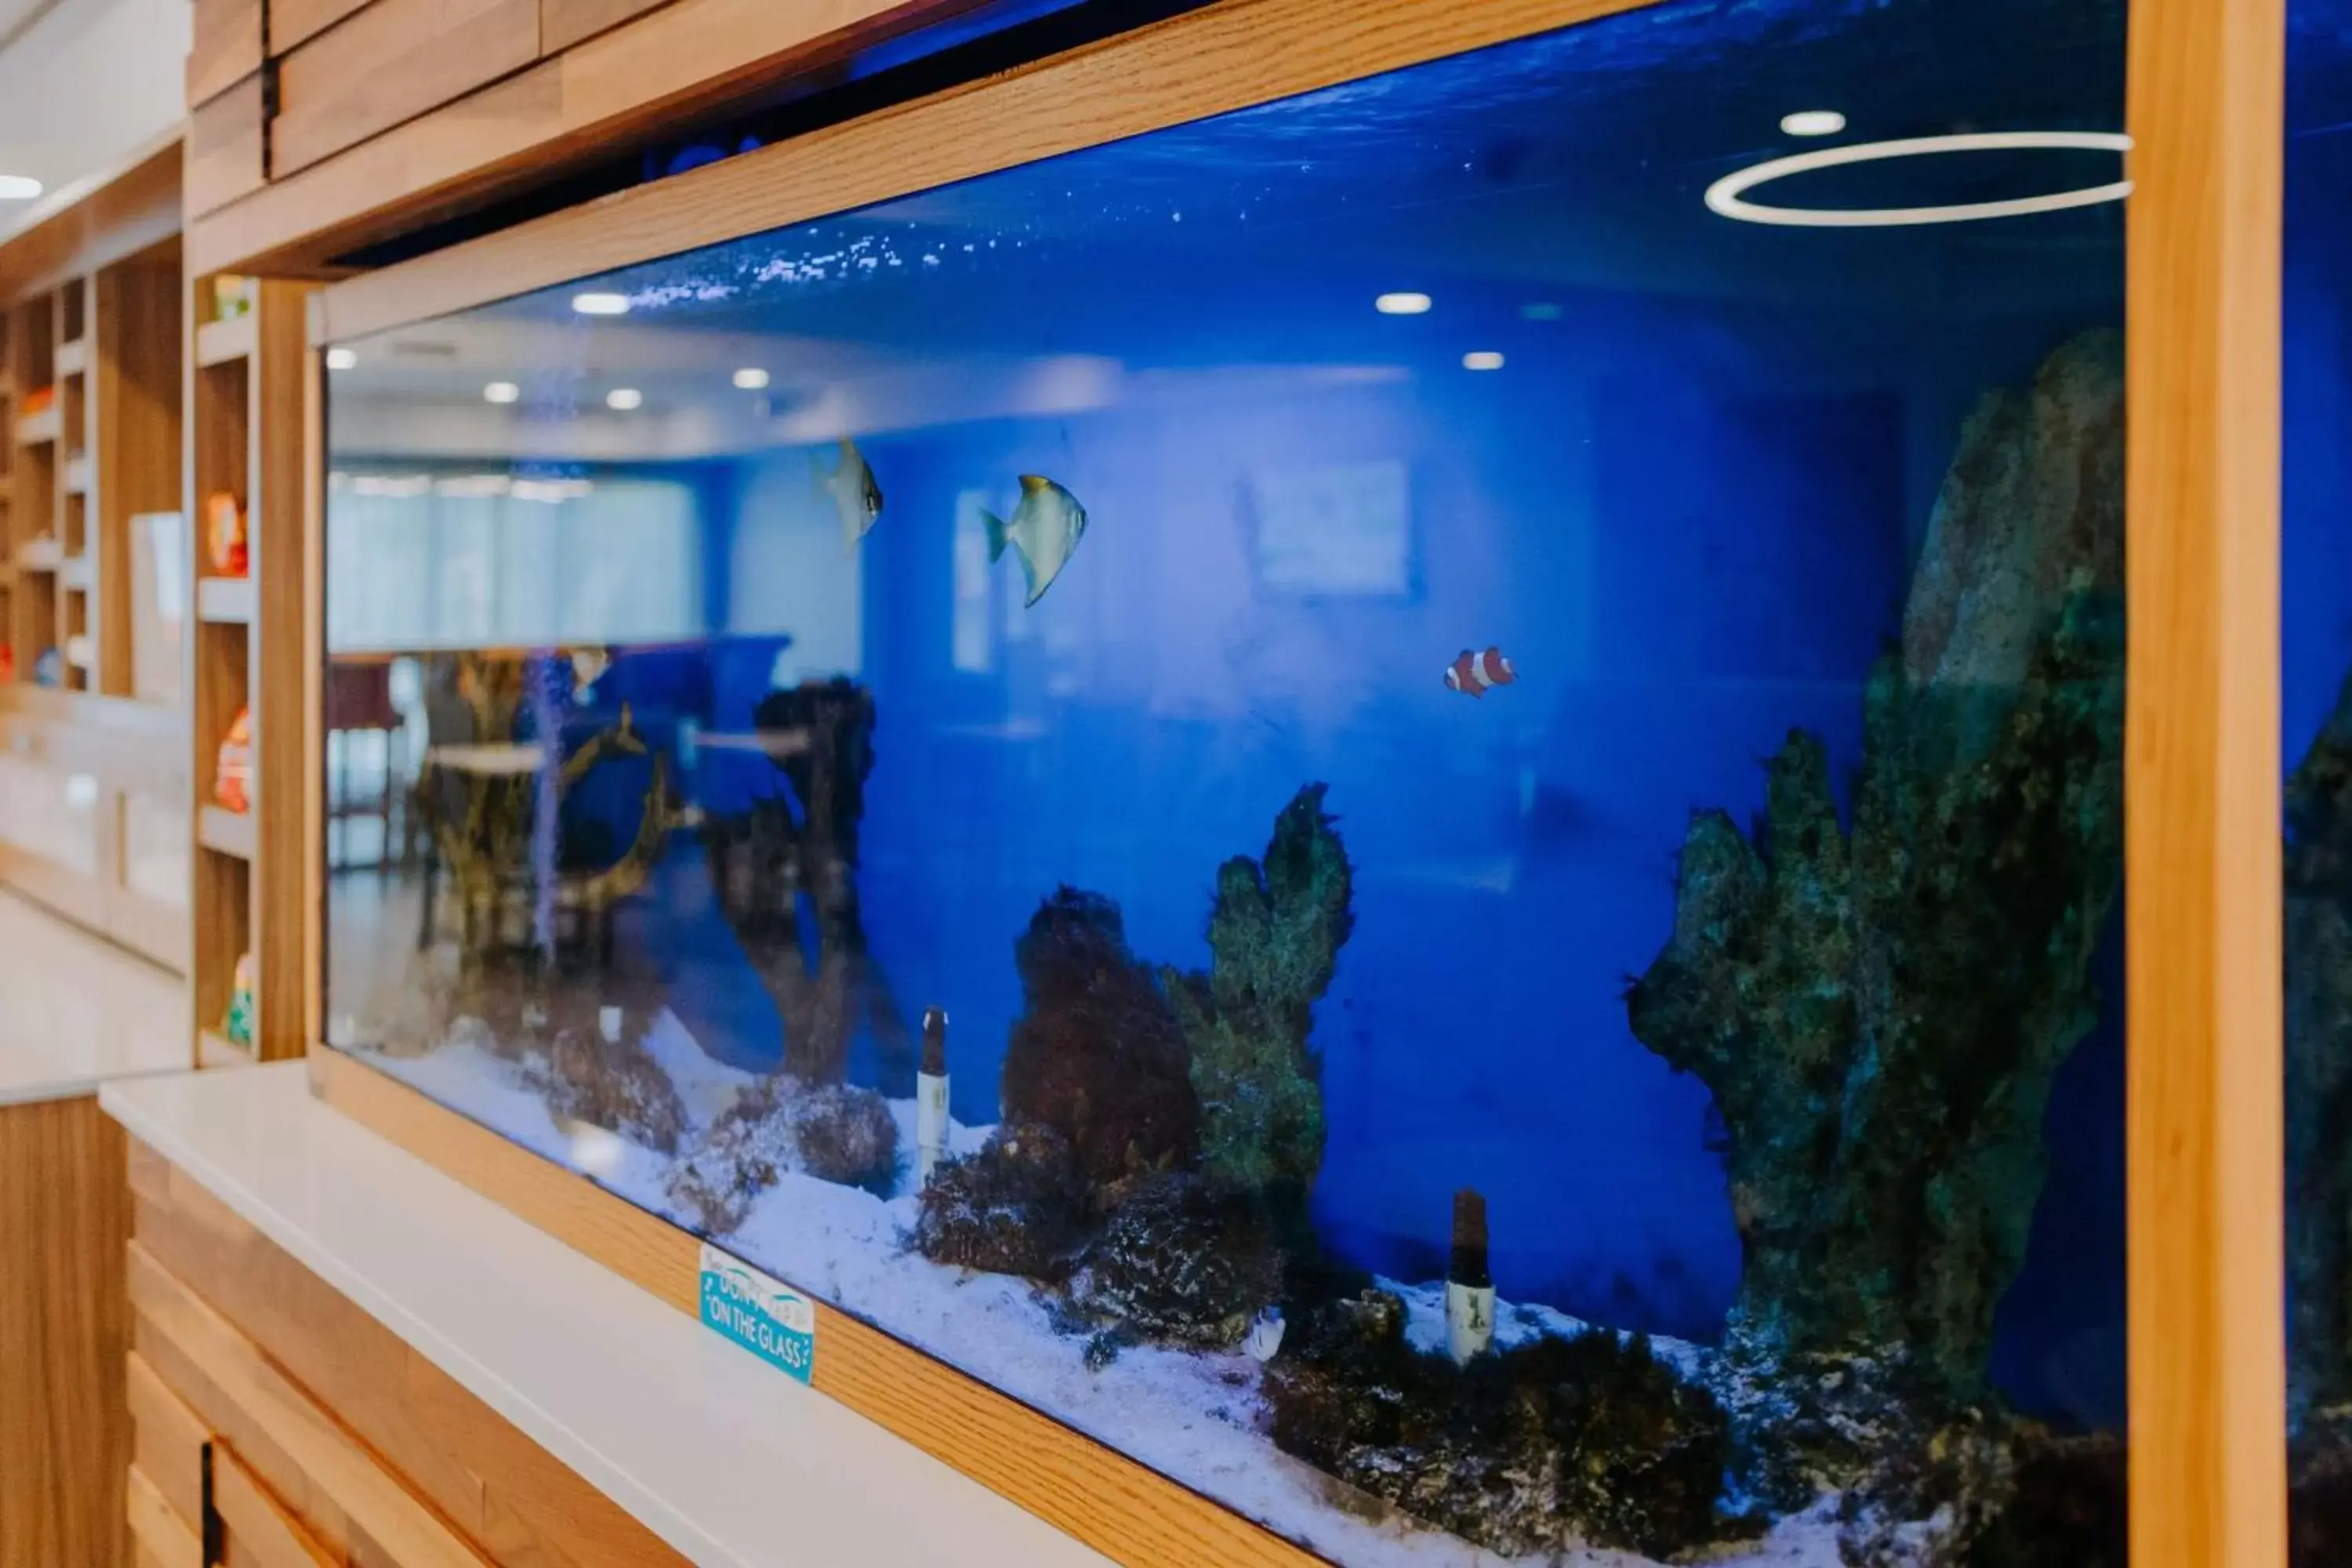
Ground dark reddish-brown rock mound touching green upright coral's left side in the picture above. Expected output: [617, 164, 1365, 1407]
[1002, 886, 1200, 1187]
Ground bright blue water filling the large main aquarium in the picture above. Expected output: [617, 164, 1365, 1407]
[332, 0, 2136, 1457]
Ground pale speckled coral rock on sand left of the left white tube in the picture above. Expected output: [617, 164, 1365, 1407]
[668, 1072, 898, 1236]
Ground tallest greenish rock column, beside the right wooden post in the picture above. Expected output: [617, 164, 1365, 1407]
[1628, 334, 2124, 1483]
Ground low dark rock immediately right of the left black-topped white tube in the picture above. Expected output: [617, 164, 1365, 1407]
[913, 1123, 1096, 1281]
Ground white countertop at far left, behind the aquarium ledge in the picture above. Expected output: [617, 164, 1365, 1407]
[0, 893, 193, 1105]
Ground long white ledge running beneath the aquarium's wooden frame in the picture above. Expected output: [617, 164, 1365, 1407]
[99, 1062, 1108, 1568]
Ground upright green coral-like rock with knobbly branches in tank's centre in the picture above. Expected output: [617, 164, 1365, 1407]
[1164, 785, 1355, 1208]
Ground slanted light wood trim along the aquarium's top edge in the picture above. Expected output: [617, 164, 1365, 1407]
[318, 0, 1651, 341]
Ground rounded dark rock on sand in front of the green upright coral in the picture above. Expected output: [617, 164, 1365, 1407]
[1077, 1173, 1282, 1349]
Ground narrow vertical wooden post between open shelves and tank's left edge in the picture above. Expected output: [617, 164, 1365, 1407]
[249, 282, 322, 1060]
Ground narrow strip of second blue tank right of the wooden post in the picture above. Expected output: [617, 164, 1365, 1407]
[2279, 0, 2352, 1568]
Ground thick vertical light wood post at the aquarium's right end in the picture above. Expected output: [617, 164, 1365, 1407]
[2124, 0, 2286, 1568]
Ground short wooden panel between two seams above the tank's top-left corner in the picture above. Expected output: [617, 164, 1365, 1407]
[270, 0, 539, 179]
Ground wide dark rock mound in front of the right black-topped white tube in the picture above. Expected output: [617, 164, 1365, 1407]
[1265, 1290, 1738, 1559]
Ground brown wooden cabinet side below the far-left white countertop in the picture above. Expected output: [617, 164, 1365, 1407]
[0, 1098, 132, 1568]
